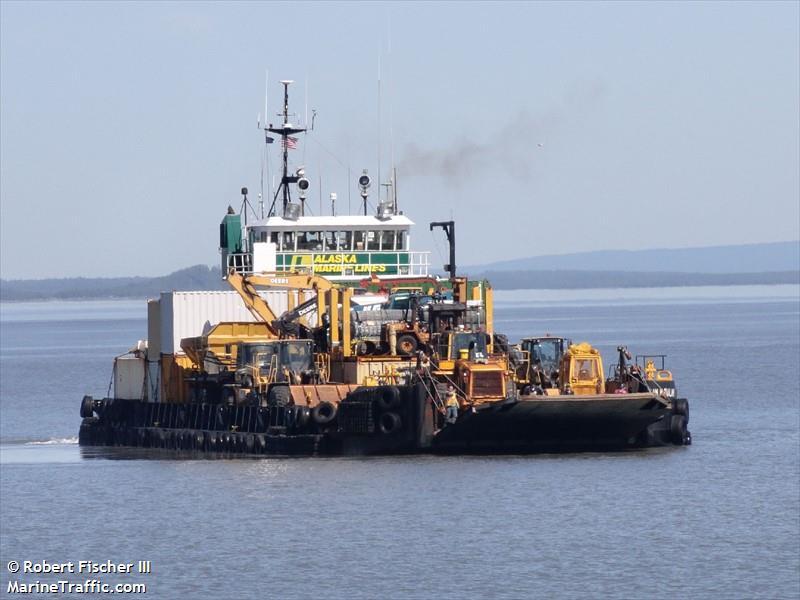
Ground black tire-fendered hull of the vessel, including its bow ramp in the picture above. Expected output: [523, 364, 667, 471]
[79, 386, 691, 456]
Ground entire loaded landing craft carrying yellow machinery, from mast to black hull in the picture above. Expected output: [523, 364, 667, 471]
[79, 81, 691, 456]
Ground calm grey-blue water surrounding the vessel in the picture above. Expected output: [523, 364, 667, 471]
[0, 286, 800, 599]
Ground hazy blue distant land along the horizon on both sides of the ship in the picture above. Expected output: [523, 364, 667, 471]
[0, 242, 800, 302]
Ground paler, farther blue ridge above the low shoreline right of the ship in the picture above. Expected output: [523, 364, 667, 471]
[468, 241, 800, 273]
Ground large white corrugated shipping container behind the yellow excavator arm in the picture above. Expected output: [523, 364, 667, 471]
[157, 290, 289, 354]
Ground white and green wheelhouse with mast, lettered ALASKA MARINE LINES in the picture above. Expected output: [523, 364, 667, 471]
[220, 81, 430, 283]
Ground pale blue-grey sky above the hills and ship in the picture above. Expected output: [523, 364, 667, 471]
[0, 1, 800, 278]
